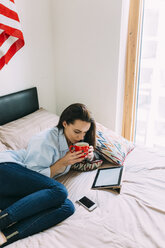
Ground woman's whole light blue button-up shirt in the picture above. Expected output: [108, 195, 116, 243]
[0, 127, 71, 178]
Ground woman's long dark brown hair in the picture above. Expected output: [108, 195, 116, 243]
[57, 103, 96, 147]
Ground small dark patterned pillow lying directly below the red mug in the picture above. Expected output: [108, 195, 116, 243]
[71, 160, 103, 171]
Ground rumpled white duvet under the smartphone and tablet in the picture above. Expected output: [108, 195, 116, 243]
[7, 147, 165, 248]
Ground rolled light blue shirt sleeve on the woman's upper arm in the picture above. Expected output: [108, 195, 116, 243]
[24, 133, 59, 177]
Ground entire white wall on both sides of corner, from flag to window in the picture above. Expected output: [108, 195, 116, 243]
[0, 0, 129, 133]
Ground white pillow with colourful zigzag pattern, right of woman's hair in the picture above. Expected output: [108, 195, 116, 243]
[96, 123, 135, 165]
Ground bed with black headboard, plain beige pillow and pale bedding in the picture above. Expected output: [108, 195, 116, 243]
[0, 87, 165, 248]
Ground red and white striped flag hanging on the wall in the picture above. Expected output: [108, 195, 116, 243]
[0, 0, 24, 70]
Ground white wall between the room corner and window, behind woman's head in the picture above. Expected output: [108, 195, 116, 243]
[52, 0, 127, 130]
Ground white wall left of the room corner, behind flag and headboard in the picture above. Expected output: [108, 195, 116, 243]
[0, 0, 56, 112]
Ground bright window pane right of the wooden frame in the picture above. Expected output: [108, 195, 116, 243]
[135, 0, 165, 149]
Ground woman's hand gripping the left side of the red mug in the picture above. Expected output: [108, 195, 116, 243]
[60, 151, 87, 166]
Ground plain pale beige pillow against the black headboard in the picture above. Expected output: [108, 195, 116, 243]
[0, 108, 59, 150]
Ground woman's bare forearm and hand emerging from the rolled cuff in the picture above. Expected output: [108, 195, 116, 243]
[50, 151, 87, 177]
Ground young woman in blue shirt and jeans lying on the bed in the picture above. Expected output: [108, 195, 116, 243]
[0, 103, 96, 247]
